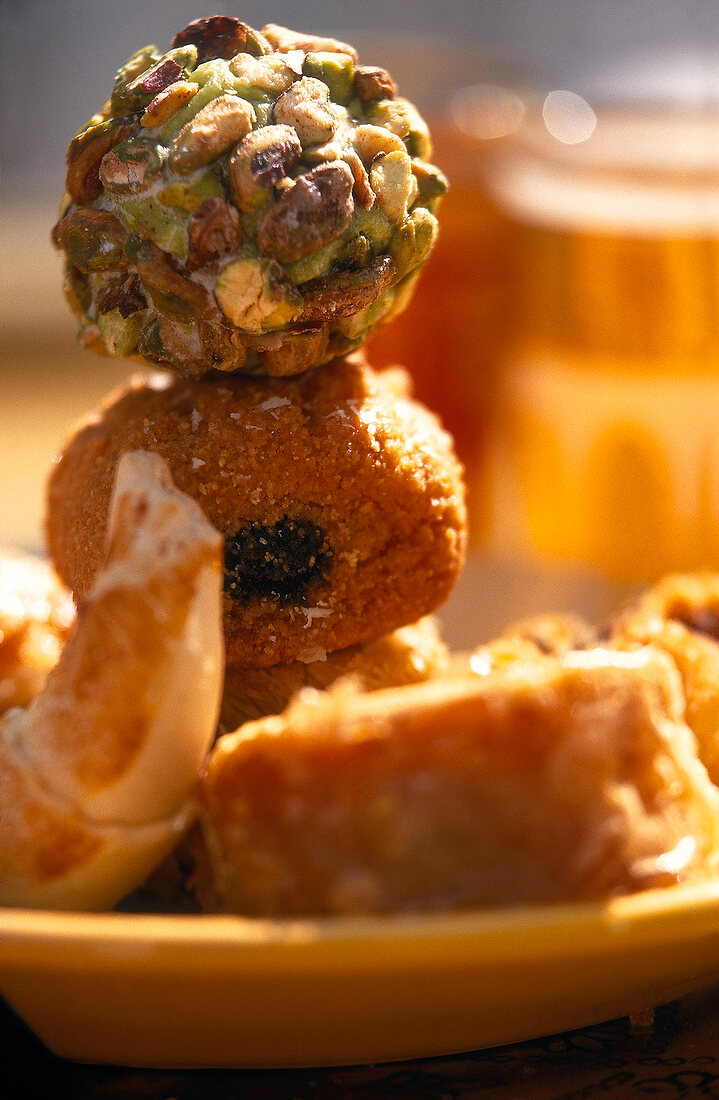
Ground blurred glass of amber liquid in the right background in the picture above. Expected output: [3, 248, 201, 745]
[479, 105, 719, 583]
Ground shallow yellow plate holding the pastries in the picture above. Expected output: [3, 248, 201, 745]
[0, 882, 719, 1067]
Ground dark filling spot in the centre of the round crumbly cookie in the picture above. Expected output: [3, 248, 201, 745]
[224, 519, 332, 604]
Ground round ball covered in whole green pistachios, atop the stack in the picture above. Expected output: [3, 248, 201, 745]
[53, 15, 446, 376]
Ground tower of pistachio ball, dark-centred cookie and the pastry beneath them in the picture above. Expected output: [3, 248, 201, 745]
[47, 17, 465, 726]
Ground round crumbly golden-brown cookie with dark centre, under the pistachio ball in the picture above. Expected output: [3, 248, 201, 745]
[47, 356, 465, 668]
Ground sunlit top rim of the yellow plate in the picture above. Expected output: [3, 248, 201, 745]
[0, 877, 719, 963]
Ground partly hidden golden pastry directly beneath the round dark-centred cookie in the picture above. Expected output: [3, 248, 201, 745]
[220, 616, 450, 730]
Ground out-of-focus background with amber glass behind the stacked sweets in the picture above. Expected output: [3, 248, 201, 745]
[0, 0, 719, 644]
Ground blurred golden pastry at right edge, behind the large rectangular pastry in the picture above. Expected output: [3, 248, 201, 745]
[611, 572, 719, 784]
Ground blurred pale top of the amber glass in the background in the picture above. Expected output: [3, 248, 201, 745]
[449, 54, 719, 235]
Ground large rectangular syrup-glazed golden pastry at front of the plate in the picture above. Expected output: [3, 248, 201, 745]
[196, 647, 719, 916]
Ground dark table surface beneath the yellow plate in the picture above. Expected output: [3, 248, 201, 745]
[0, 987, 719, 1100]
